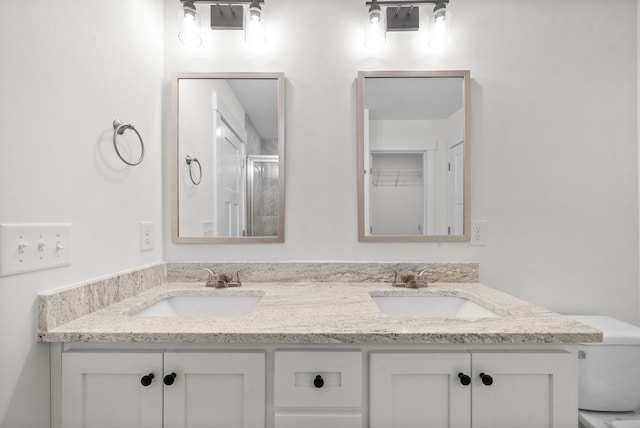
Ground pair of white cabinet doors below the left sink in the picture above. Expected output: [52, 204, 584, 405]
[61, 352, 265, 428]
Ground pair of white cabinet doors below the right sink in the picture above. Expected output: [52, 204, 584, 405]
[369, 351, 578, 428]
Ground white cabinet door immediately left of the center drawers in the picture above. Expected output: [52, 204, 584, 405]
[164, 352, 266, 428]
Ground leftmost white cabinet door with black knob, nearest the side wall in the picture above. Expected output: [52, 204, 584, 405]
[61, 352, 162, 428]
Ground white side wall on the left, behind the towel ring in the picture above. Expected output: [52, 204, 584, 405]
[0, 0, 163, 428]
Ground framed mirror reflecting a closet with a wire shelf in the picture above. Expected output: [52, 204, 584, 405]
[358, 71, 470, 241]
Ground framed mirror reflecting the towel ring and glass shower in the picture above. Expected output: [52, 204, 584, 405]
[172, 73, 284, 243]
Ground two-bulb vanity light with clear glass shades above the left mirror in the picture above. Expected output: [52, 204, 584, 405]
[178, 0, 267, 46]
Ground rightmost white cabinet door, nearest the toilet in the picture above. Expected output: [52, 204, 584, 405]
[472, 352, 578, 428]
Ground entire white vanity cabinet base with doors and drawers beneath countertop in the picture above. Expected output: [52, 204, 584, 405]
[52, 343, 578, 428]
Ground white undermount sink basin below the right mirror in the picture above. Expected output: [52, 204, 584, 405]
[371, 296, 499, 318]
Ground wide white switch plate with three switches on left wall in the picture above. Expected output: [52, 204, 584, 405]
[0, 223, 71, 276]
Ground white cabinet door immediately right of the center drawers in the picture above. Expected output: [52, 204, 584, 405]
[369, 353, 471, 428]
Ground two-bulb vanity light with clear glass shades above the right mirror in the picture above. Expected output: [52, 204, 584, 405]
[365, 0, 451, 48]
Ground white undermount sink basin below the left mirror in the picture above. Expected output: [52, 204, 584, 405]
[136, 296, 262, 317]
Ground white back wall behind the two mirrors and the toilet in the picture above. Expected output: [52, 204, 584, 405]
[164, 0, 639, 322]
